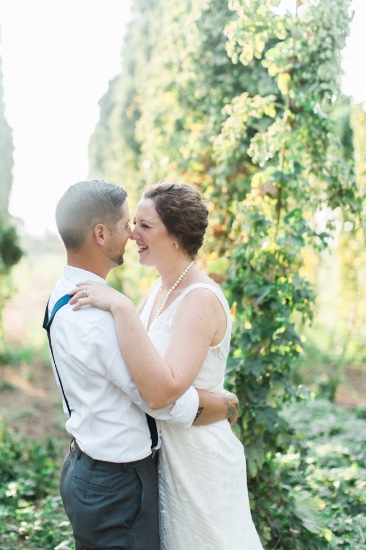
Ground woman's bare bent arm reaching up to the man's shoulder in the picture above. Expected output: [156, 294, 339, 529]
[70, 283, 229, 410]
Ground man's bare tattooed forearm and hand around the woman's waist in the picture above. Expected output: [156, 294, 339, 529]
[192, 390, 239, 426]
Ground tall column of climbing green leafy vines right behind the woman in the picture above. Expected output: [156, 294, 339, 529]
[215, 0, 361, 549]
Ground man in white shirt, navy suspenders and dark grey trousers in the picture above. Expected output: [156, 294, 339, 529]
[46, 180, 237, 550]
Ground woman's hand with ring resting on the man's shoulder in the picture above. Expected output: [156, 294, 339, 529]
[69, 281, 127, 311]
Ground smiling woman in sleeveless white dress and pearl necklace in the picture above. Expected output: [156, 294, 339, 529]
[70, 183, 262, 550]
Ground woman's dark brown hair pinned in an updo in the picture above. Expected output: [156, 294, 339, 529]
[142, 182, 208, 259]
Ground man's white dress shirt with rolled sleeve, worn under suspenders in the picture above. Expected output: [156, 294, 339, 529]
[49, 265, 198, 462]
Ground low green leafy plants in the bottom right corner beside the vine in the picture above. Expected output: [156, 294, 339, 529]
[242, 396, 366, 550]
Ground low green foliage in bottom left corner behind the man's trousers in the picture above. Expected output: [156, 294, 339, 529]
[0, 425, 73, 550]
